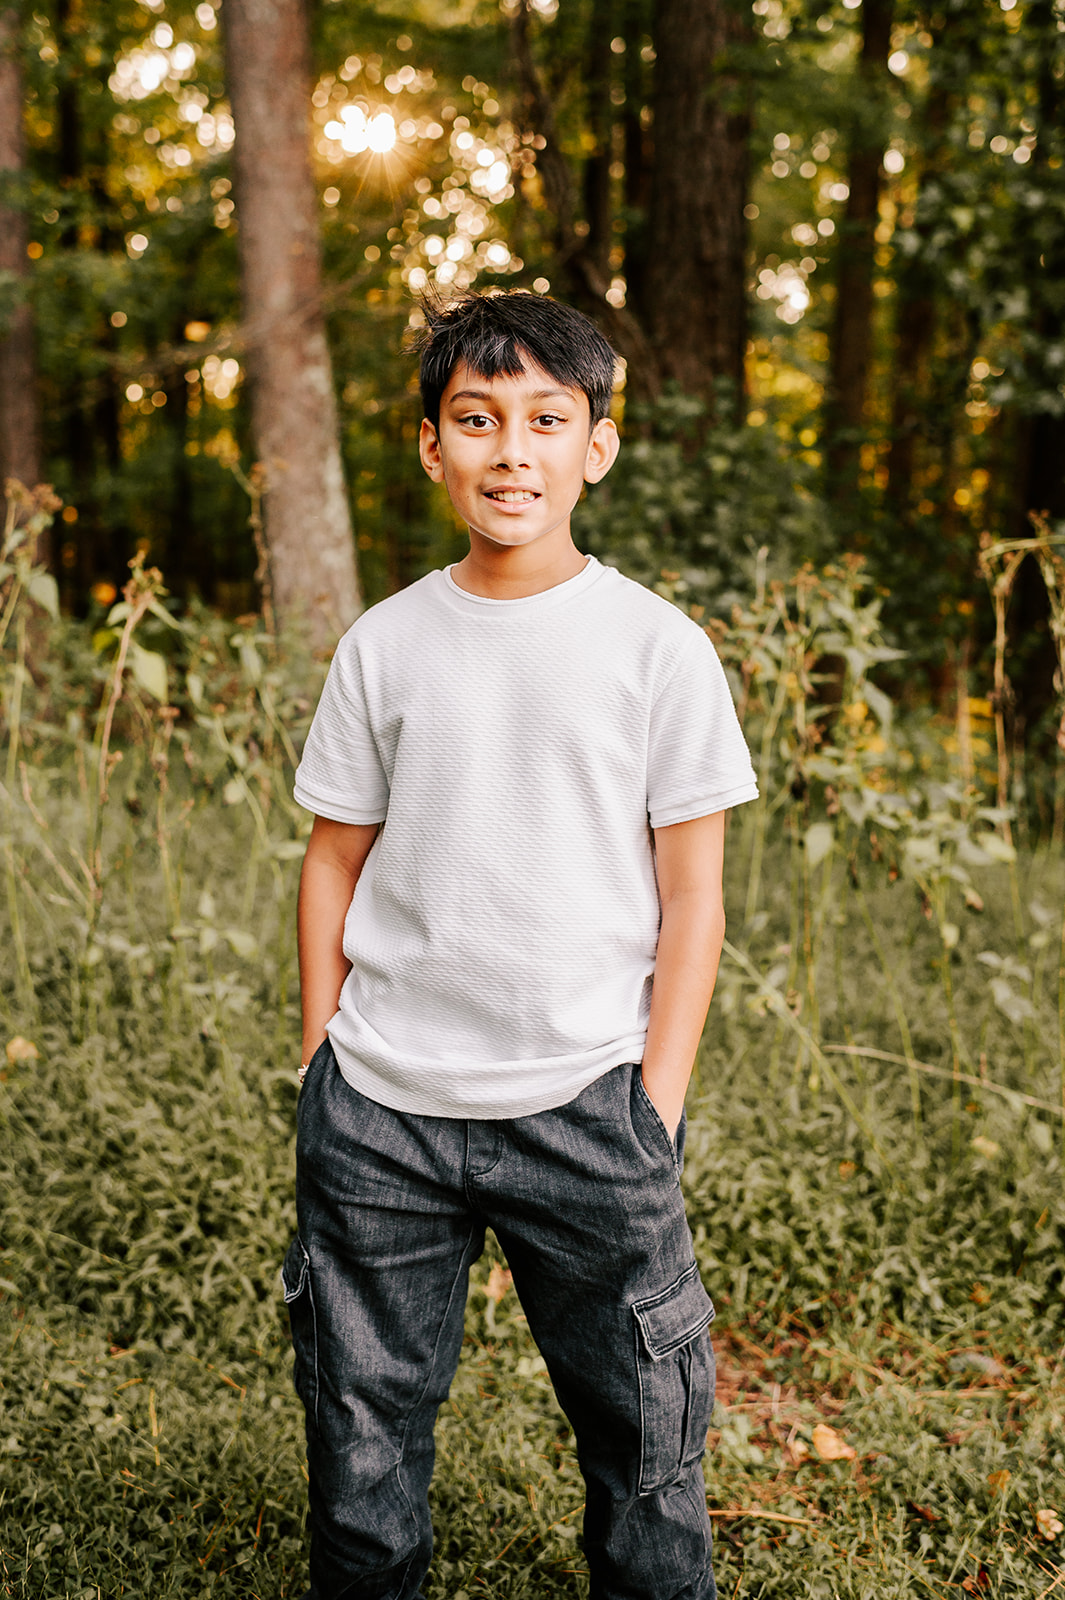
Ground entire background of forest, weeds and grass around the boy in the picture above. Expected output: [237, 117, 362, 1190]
[0, 9, 1065, 1600]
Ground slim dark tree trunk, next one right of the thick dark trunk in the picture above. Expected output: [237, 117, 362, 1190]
[825, 0, 894, 496]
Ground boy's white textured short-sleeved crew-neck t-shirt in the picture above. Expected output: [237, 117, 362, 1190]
[296, 558, 758, 1118]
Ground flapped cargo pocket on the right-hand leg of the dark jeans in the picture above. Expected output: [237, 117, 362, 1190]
[632, 1261, 713, 1494]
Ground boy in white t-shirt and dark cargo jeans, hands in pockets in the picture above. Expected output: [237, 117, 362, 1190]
[283, 293, 756, 1600]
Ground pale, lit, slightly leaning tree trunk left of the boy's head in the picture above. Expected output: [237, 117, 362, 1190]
[222, 0, 360, 646]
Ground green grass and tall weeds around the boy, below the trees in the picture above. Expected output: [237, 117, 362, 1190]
[0, 534, 1065, 1600]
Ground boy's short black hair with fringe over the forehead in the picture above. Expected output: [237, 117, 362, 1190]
[413, 290, 616, 427]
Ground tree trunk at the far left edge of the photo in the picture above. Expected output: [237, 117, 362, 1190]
[0, 6, 50, 560]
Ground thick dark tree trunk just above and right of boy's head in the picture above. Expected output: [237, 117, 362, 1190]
[641, 0, 750, 400]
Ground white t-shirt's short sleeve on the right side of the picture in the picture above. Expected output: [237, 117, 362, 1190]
[648, 629, 758, 827]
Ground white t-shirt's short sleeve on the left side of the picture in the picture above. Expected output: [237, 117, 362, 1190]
[293, 640, 389, 824]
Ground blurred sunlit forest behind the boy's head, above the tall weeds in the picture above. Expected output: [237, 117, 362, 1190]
[0, 0, 1065, 707]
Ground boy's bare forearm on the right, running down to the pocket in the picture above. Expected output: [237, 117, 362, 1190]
[643, 891, 724, 1134]
